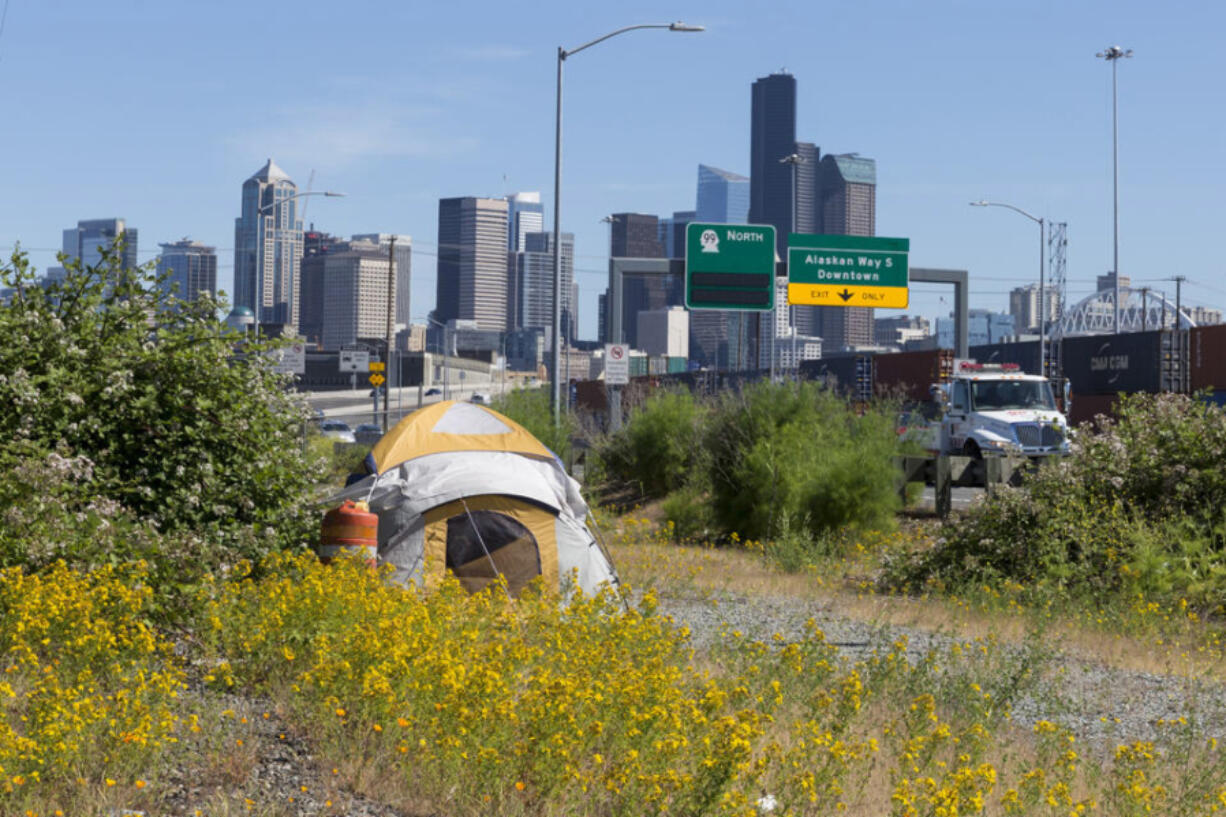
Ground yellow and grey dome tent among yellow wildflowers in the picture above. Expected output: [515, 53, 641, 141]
[332, 401, 617, 595]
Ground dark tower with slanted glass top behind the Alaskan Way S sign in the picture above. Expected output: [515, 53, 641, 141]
[814, 153, 877, 350]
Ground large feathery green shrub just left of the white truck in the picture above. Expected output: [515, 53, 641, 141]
[706, 383, 899, 540]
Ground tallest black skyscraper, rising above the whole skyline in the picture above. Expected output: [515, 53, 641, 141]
[749, 74, 796, 258]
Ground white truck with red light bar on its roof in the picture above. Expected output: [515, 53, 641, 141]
[934, 361, 1069, 459]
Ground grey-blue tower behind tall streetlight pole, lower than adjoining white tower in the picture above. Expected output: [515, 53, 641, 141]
[506, 232, 576, 341]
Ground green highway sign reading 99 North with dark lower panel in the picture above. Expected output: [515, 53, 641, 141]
[685, 222, 775, 312]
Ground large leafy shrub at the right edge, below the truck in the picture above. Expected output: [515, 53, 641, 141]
[885, 394, 1226, 606]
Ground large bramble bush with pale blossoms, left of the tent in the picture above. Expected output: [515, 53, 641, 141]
[0, 243, 318, 578]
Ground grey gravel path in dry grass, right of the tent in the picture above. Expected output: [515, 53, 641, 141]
[660, 586, 1226, 751]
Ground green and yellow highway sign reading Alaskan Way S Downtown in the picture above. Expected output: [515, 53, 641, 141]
[787, 233, 911, 309]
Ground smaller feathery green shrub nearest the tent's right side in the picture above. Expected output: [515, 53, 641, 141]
[600, 391, 706, 497]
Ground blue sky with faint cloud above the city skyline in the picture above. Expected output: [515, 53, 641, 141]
[0, 0, 1226, 337]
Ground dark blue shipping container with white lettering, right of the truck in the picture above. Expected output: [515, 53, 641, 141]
[1063, 331, 1187, 396]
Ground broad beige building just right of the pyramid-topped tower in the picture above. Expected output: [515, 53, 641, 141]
[316, 240, 395, 350]
